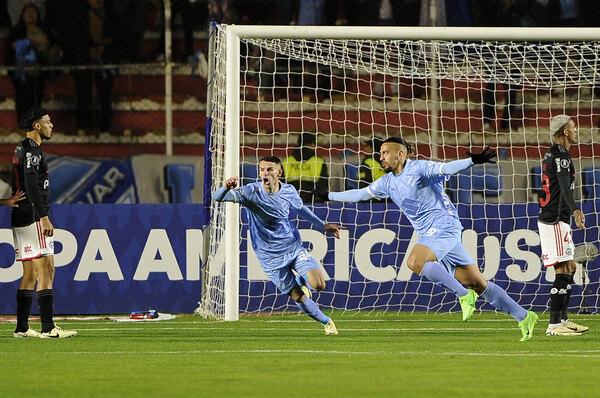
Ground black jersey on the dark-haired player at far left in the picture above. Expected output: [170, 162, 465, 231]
[11, 138, 50, 227]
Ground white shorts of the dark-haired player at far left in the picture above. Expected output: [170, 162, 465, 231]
[12, 221, 54, 261]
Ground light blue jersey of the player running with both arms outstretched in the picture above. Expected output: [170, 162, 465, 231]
[367, 160, 462, 237]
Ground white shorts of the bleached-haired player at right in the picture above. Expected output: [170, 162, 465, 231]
[538, 221, 575, 267]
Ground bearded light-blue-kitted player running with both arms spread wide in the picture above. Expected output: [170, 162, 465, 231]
[318, 137, 538, 341]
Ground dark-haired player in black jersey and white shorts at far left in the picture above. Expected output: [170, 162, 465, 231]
[11, 108, 77, 338]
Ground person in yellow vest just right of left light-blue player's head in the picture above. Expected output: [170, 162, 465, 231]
[282, 131, 329, 203]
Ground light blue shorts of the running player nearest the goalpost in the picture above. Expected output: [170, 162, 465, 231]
[260, 247, 319, 294]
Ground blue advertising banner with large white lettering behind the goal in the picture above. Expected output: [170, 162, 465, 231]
[0, 201, 600, 314]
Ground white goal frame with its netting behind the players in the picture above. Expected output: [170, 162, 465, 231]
[198, 26, 600, 320]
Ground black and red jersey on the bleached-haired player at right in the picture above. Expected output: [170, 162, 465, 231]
[539, 144, 577, 224]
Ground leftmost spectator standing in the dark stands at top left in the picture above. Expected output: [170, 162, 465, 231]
[7, 3, 60, 124]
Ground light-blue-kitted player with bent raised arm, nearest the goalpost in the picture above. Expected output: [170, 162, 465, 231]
[213, 156, 342, 334]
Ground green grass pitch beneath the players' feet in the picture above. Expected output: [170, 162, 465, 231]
[0, 313, 600, 398]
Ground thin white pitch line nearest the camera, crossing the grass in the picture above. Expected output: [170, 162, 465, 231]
[4, 350, 600, 358]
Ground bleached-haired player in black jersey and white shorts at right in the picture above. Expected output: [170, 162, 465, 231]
[538, 115, 588, 336]
